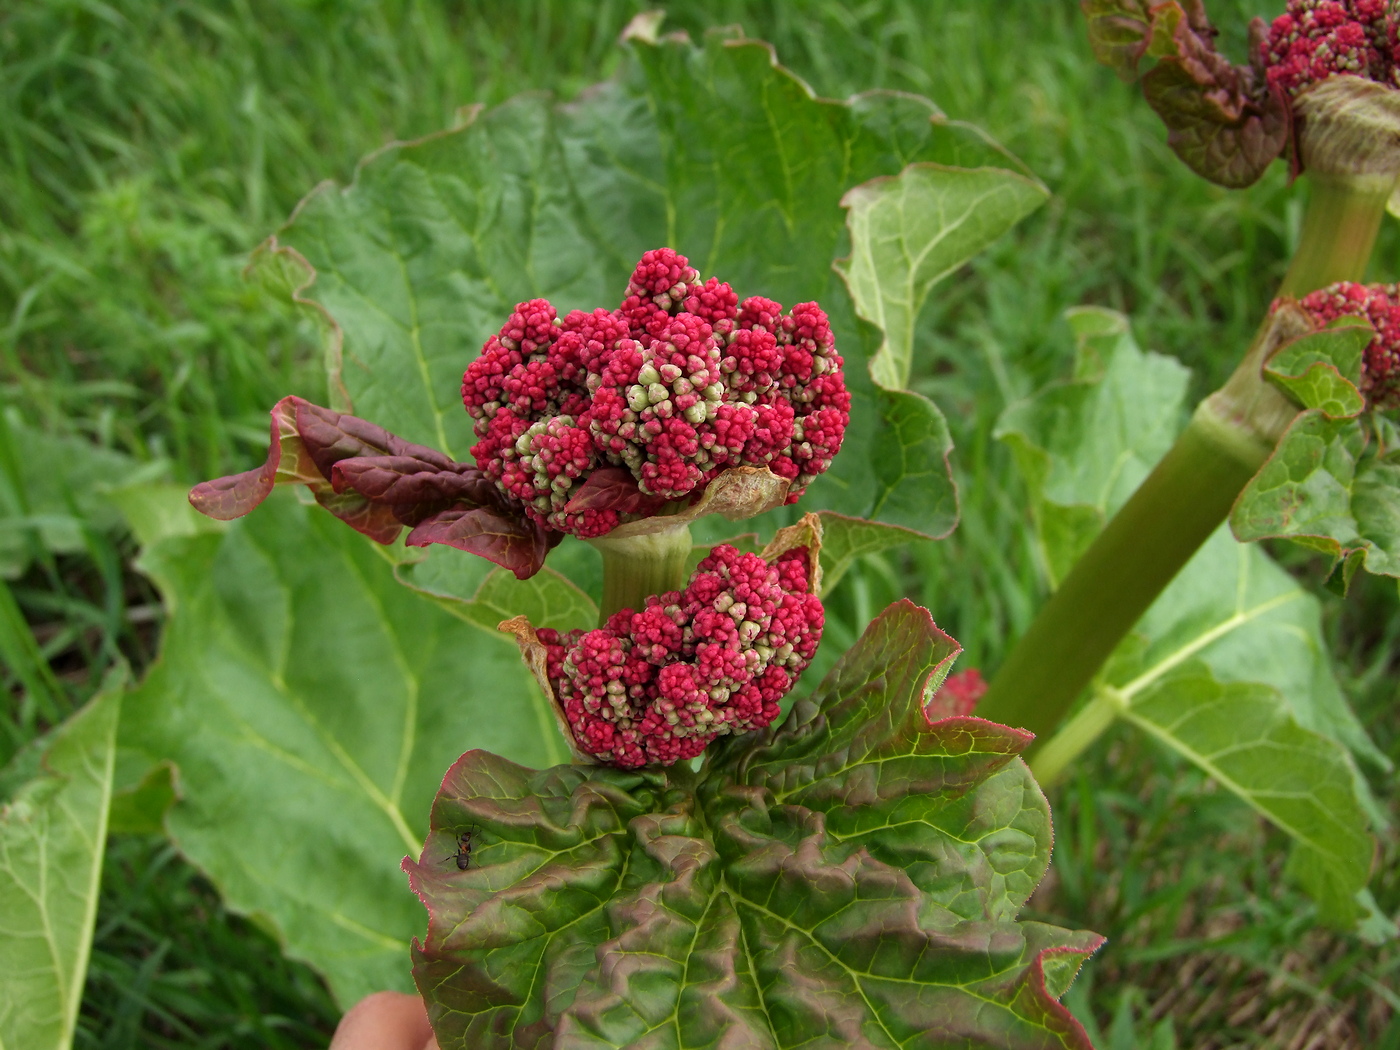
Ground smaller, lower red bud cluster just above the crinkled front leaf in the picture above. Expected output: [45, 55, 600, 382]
[539, 545, 823, 769]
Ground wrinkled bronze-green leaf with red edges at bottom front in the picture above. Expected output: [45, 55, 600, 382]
[405, 602, 1102, 1050]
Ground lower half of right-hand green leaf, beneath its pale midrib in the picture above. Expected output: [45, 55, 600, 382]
[1117, 659, 1373, 924]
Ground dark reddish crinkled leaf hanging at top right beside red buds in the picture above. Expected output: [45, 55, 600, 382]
[1079, 0, 1292, 189]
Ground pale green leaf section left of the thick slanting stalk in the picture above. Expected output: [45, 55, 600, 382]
[995, 307, 1190, 584]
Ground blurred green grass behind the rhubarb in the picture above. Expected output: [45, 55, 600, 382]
[0, 0, 1400, 1050]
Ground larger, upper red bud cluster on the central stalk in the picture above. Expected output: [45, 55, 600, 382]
[462, 248, 851, 538]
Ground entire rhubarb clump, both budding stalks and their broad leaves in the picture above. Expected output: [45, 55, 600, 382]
[68, 0, 1400, 1049]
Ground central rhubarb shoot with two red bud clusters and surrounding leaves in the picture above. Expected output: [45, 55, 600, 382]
[90, 18, 1100, 1047]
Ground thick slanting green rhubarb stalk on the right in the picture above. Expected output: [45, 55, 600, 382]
[977, 176, 1394, 776]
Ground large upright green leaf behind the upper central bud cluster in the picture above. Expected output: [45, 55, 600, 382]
[259, 20, 1043, 533]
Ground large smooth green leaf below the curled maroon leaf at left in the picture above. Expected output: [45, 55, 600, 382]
[122, 493, 567, 1005]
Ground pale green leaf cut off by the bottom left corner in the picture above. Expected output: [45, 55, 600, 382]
[0, 682, 125, 1050]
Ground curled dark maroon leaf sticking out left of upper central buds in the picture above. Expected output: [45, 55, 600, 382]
[189, 396, 548, 580]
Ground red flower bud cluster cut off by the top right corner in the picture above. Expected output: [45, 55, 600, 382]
[1264, 0, 1400, 97]
